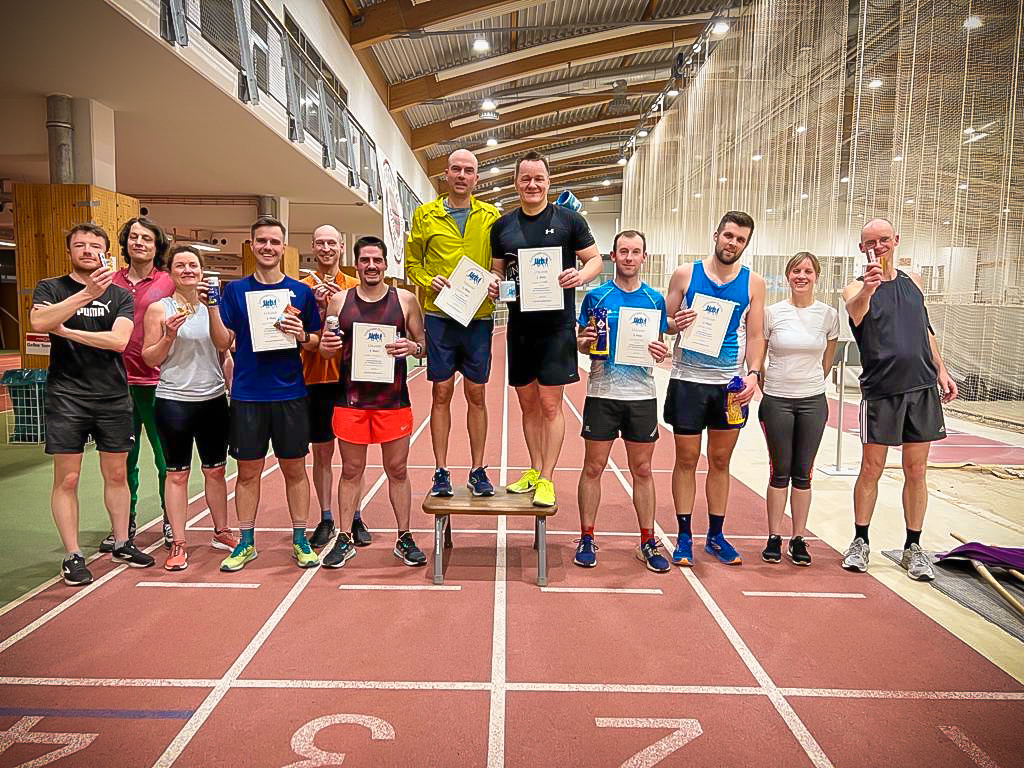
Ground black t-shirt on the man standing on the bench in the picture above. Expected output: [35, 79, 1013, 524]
[490, 204, 594, 330]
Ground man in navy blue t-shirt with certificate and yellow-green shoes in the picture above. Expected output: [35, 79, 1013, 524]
[200, 216, 321, 570]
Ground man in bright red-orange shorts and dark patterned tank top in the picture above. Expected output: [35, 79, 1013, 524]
[321, 237, 427, 568]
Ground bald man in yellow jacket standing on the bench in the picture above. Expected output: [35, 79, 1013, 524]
[406, 150, 499, 496]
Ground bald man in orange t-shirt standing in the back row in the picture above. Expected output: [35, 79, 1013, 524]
[302, 224, 360, 549]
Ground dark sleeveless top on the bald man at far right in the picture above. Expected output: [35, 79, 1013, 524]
[850, 270, 939, 400]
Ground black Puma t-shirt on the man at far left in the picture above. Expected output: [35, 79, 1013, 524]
[32, 274, 135, 398]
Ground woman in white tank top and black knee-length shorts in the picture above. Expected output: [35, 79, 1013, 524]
[142, 246, 238, 570]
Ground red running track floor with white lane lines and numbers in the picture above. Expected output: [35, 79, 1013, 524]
[0, 334, 1024, 768]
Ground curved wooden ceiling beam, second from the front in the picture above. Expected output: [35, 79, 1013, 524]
[387, 24, 705, 112]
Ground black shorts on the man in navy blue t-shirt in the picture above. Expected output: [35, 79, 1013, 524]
[228, 397, 309, 461]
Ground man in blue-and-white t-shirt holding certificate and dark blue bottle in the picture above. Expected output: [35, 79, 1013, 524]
[573, 229, 672, 573]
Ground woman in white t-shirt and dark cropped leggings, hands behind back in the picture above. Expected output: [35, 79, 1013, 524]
[758, 251, 839, 565]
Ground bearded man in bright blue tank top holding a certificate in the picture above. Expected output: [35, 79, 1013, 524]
[665, 211, 765, 565]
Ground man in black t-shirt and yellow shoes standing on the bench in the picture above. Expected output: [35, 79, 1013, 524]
[490, 152, 601, 507]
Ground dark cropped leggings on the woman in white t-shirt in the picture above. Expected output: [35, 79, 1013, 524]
[758, 393, 828, 490]
